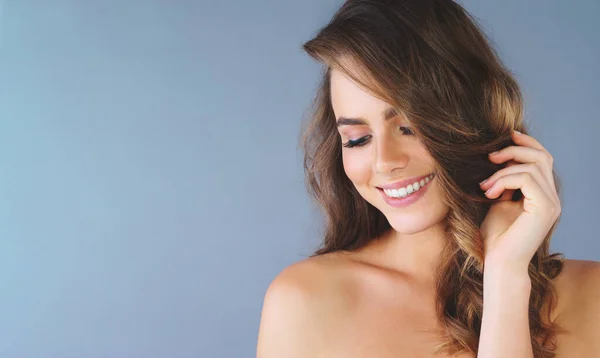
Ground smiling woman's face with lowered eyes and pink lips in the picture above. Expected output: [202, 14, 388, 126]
[331, 70, 448, 234]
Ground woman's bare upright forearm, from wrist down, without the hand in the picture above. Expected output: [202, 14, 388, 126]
[477, 262, 533, 358]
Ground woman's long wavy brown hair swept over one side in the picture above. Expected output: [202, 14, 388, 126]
[301, 0, 564, 357]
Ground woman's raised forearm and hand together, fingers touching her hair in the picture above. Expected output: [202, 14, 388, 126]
[479, 131, 561, 358]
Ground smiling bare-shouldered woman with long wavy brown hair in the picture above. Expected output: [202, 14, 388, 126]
[257, 0, 600, 358]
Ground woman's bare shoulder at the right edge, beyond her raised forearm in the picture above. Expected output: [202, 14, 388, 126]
[555, 260, 600, 357]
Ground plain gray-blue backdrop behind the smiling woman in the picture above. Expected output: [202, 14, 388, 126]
[0, 0, 600, 358]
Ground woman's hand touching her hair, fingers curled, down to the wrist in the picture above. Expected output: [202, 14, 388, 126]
[480, 131, 561, 272]
